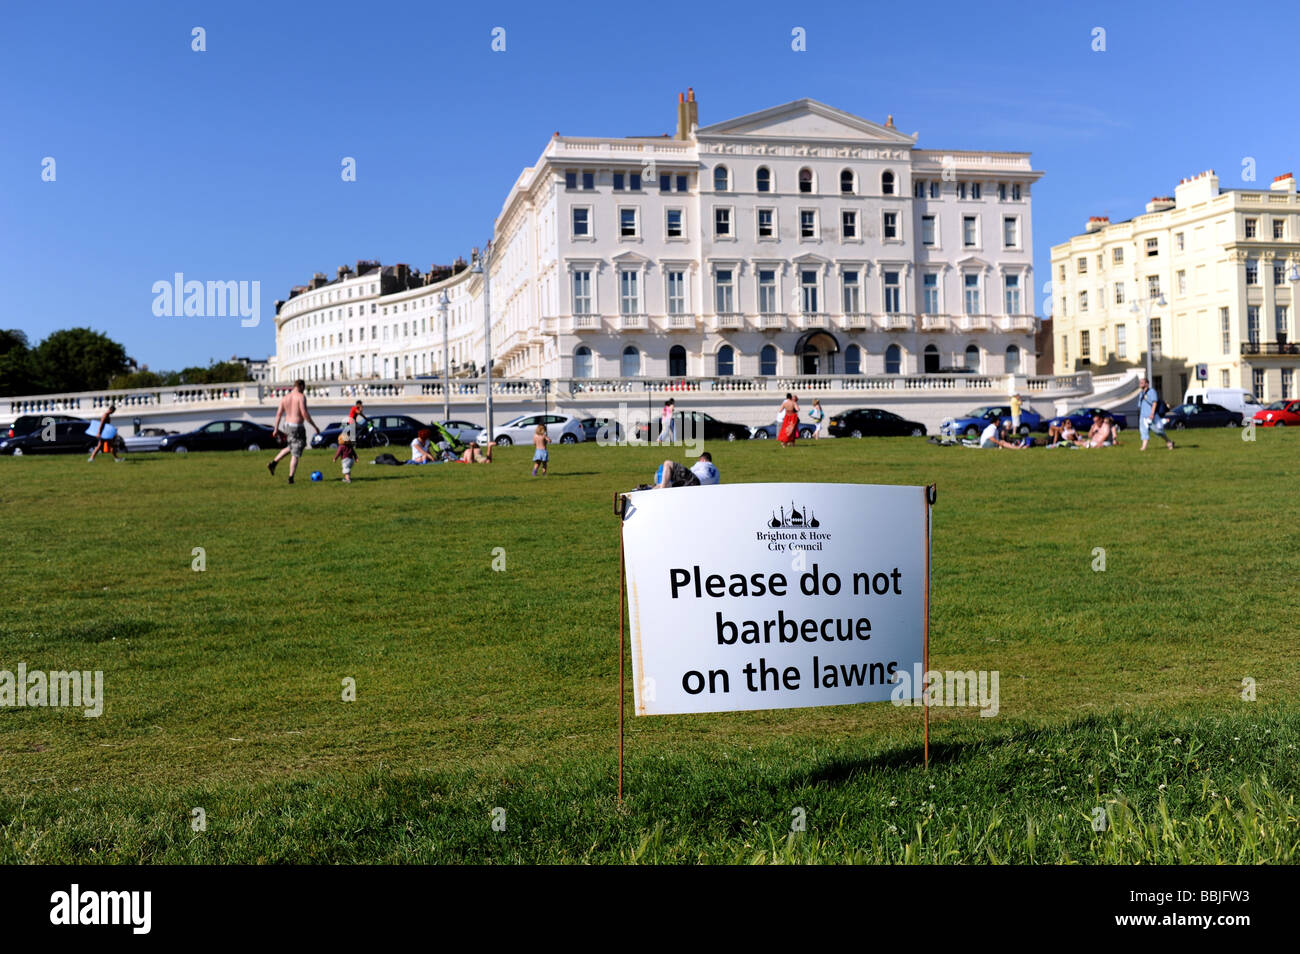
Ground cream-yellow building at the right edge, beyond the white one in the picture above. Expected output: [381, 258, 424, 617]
[1052, 172, 1300, 404]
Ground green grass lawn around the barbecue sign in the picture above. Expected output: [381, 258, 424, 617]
[0, 430, 1300, 863]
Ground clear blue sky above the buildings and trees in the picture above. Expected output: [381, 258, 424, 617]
[0, 0, 1300, 369]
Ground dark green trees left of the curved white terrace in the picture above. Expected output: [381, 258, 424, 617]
[0, 328, 252, 396]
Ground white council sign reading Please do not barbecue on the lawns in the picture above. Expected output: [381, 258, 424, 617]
[623, 483, 928, 715]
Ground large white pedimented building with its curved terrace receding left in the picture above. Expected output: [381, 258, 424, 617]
[274, 92, 1041, 381]
